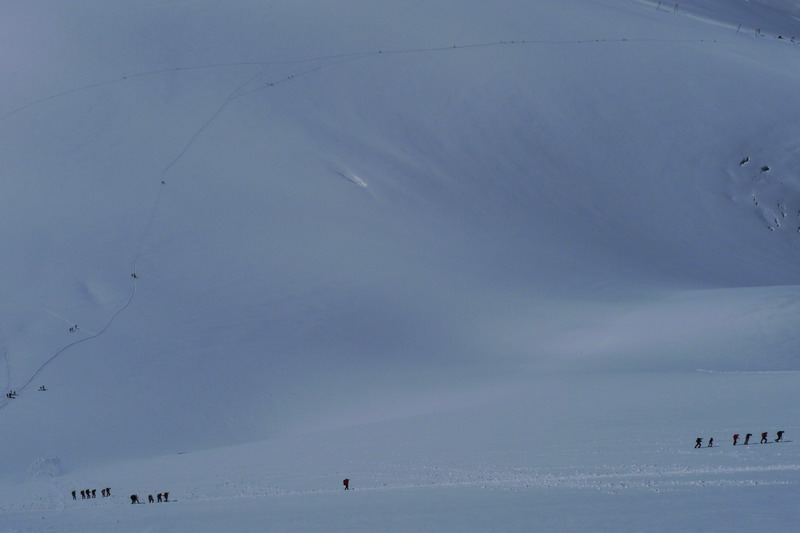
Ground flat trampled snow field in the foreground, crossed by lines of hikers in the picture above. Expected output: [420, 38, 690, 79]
[2, 372, 800, 531]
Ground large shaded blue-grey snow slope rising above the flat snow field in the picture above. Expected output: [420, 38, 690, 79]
[0, 0, 800, 482]
